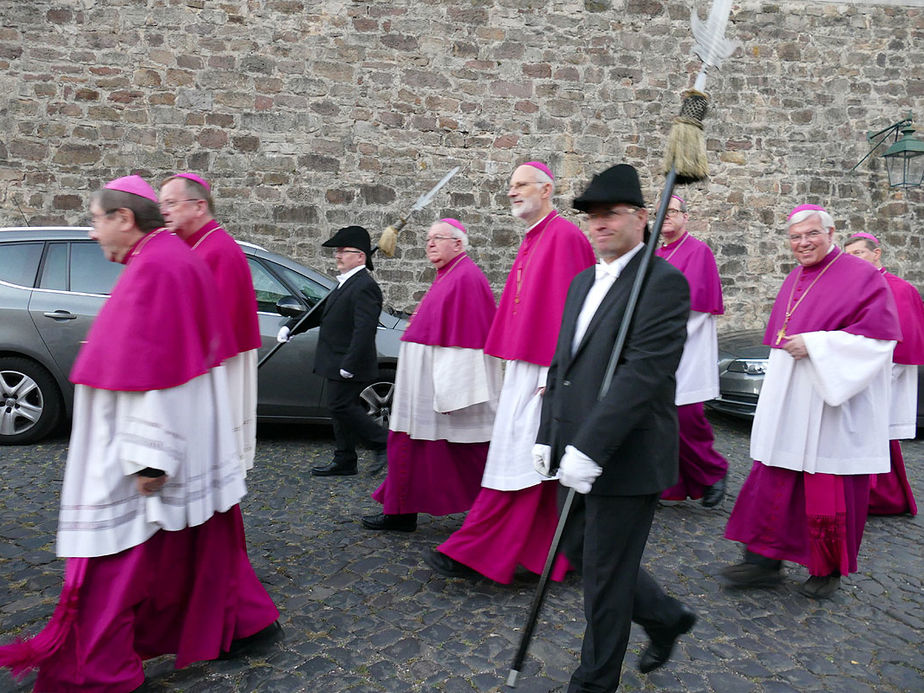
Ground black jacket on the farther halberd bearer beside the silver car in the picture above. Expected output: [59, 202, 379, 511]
[314, 269, 382, 382]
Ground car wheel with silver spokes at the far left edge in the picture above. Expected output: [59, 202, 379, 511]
[0, 356, 61, 445]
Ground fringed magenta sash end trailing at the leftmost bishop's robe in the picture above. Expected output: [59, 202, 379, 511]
[0, 558, 89, 679]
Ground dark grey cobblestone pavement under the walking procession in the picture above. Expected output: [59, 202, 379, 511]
[0, 416, 924, 693]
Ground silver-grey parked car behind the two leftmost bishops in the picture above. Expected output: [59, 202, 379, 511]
[0, 227, 407, 444]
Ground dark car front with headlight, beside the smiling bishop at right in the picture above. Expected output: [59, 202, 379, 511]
[706, 330, 924, 429]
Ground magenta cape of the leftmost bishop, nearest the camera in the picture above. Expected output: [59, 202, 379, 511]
[70, 229, 236, 391]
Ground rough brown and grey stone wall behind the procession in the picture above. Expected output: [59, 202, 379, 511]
[0, 0, 924, 327]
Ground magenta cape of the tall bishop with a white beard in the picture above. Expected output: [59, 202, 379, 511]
[484, 211, 595, 366]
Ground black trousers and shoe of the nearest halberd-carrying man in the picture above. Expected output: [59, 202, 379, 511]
[559, 486, 681, 693]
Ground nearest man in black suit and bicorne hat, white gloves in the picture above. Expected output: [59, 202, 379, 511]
[534, 164, 696, 693]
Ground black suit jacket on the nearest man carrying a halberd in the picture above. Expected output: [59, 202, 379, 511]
[537, 248, 690, 496]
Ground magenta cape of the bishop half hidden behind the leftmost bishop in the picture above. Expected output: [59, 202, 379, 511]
[186, 219, 262, 353]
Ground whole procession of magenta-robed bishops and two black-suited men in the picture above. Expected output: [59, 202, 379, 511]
[0, 161, 924, 691]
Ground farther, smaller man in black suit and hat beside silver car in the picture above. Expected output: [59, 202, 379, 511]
[278, 226, 388, 476]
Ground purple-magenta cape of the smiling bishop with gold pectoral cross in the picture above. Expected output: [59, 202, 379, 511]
[764, 248, 901, 347]
